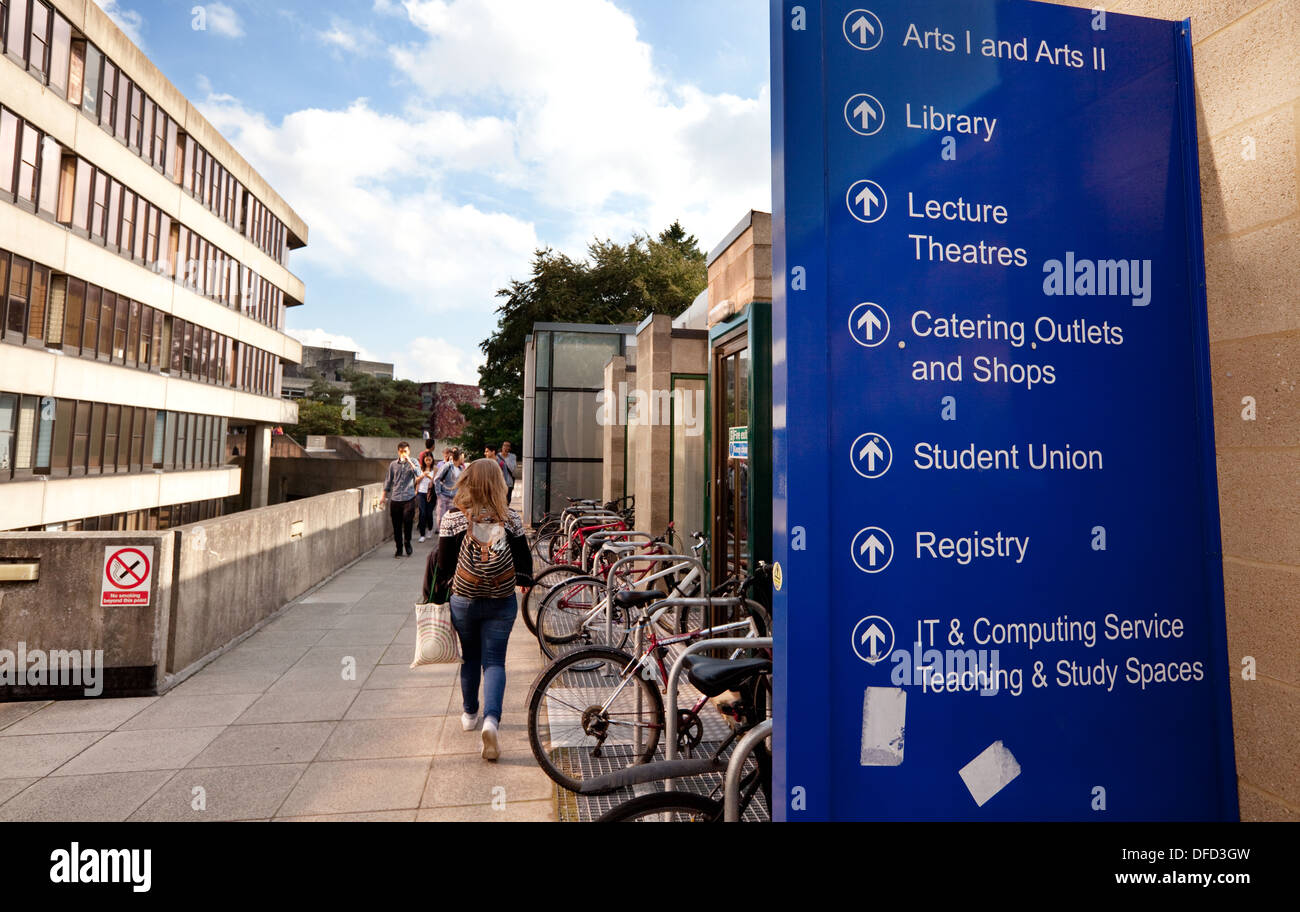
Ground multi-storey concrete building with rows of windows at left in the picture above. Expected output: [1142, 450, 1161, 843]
[0, 0, 307, 530]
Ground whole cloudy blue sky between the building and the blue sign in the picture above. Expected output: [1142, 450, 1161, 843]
[100, 0, 771, 382]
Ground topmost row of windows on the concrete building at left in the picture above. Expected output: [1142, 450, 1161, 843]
[0, 0, 287, 265]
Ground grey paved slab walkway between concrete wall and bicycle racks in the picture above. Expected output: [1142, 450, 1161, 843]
[0, 543, 555, 821]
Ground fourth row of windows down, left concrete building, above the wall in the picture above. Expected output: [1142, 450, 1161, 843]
[0, 392, 228, 481]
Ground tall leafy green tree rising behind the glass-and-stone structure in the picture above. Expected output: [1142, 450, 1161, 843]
[454, 222, 707, 453]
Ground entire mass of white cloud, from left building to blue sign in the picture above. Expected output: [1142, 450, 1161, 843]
[199, 0, 771, 383]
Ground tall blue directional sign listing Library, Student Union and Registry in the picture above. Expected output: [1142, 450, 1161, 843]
[771, 0, 1238, 821]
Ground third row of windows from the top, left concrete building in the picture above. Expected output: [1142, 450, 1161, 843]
[0, 249, 281, 396]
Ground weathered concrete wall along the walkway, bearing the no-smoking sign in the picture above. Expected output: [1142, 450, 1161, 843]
[0, 485, 391, 700]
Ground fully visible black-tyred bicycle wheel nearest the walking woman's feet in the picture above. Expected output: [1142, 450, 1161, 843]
[528, 646, 664, 791]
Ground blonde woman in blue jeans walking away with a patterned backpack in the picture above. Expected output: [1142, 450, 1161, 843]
[423, 459, 533, 760]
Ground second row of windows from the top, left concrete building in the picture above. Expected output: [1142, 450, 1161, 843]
[0, 108, 285, 329]
